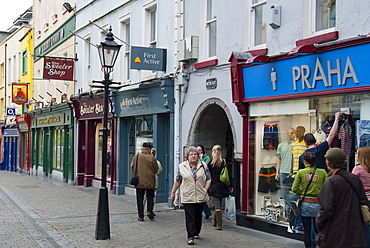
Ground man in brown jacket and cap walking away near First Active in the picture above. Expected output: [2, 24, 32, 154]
[131, 142, 158, 221]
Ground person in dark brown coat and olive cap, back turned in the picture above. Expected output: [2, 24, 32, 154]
[316, 148, 370, 248]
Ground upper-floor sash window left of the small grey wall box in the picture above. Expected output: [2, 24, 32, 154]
[252, 0, 266, 46]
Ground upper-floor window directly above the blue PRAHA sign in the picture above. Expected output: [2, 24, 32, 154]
[315, 0, 336, 32]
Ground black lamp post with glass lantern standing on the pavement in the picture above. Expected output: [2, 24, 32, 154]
[95, 27, 121, 240]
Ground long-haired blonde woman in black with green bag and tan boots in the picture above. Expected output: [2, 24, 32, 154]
[208, 145, 234, 230]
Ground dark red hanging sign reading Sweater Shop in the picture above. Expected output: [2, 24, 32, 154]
[43, 59, 74, 81]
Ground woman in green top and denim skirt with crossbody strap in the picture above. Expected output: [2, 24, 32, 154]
[292, 152, 328, 248]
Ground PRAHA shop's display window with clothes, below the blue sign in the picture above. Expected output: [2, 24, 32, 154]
[248, 92, 370, 222]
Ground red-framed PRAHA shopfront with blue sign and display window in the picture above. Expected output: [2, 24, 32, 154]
[230, 37, 370, 238]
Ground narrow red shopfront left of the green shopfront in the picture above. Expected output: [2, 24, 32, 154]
[16, 116, 31, 172]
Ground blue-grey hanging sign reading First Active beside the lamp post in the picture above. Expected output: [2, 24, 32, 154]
[130, 46, 167, 71]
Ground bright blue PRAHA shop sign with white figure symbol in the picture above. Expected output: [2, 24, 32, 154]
[243, 44, 370, 101]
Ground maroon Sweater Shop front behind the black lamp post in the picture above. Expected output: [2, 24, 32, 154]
[73, 94, 116, 192]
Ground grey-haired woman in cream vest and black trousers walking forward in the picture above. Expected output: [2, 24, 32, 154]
[171, 146, 211, 245]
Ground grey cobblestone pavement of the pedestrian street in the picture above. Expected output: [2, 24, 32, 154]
[0, 171, 303, 248]
